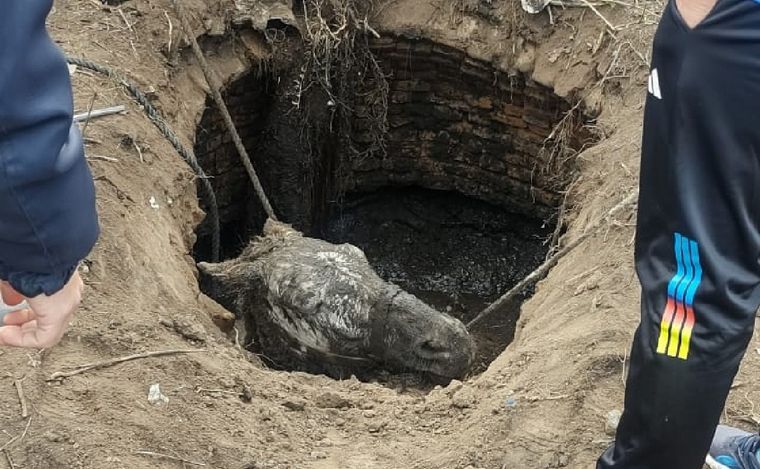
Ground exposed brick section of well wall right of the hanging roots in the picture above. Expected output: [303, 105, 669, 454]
[344, 38, 582, 217]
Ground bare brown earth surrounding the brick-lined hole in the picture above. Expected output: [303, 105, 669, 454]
[0, 0, 760, 469]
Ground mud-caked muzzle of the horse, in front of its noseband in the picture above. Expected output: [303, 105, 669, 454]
[370, 285, 475, 378]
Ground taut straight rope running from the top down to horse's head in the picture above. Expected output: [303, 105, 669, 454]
[172, 0, 277, 221]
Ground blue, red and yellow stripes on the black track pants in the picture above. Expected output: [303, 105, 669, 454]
[657, 233, 702, 360]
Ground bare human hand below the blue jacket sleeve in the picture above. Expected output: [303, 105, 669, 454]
[0, 272, 84, 348]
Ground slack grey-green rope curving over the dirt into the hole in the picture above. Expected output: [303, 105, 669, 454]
[66, 56, 220, 262]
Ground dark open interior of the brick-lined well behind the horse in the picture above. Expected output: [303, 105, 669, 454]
[190, 38, 590, 380]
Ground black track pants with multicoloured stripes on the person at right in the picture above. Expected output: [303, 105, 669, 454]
[597, 0, 760, 469]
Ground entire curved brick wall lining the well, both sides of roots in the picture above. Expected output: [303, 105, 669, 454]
[195, 37, 585, 258]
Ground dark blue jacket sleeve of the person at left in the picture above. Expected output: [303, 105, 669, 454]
[0, 0, 98, 297]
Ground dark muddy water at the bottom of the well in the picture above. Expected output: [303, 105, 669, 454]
[319, 188, 553, 372]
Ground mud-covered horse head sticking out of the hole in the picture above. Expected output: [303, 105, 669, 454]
[198, 220, 475, 378]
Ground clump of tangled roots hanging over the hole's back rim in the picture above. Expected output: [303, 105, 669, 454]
[294, 0, 389, 195]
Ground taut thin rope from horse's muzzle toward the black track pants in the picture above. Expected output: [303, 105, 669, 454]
[467, 189, 638, 329]
